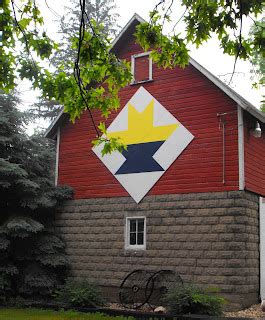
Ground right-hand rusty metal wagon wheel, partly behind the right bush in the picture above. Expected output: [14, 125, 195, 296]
[145, 270, 183, 309]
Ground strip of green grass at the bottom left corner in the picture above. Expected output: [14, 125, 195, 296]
[0, 308, 129, 320]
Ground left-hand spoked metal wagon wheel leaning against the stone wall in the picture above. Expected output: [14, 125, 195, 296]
[119, 270, 152, 309]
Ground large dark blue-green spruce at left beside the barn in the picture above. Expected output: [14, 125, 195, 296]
[0, 94, 71, 298]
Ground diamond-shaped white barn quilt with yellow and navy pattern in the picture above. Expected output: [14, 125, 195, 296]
[93, 87, 194, 203]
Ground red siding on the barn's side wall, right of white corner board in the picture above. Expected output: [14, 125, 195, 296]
[244, 113, 265, 196]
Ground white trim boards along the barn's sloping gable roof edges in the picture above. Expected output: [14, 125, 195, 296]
[45, 13, 265, 137]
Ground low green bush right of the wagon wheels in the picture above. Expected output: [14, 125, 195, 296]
[163, 285, 226, 316]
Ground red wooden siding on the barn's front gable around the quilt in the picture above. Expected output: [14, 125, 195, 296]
[59, 38, 238, 198]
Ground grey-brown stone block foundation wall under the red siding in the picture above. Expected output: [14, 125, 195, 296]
[55, 191, 259, 306]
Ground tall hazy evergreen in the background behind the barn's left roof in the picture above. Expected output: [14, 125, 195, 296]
[29, 0, 119, 121]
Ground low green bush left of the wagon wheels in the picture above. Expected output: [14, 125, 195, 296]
[58, 281, 105, 308]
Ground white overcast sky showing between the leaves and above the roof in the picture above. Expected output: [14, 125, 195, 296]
[20, 0, 264, 131]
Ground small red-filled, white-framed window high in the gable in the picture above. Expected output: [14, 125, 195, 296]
[132, 52, 153, 84]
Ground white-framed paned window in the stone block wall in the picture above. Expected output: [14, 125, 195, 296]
[125, 217, 146, 249]
